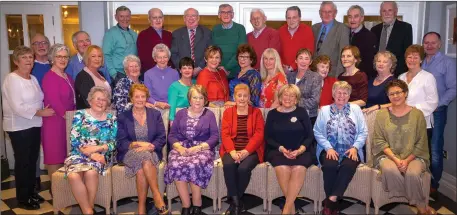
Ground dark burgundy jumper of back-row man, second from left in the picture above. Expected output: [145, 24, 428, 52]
[136, 26, 172, 73]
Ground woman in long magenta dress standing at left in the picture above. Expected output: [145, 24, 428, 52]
[41, 44, 76, 186]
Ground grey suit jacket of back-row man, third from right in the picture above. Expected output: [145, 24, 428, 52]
[312, 20, 349, 77]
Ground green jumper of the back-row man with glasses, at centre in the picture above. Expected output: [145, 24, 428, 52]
[212, 22, 246, 79]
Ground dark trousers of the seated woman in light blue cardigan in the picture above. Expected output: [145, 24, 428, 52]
[319, 150, 360, 199]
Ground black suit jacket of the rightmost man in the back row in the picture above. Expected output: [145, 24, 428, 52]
[371, 20, 413, 77]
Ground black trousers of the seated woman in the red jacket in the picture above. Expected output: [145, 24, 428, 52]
[222, 152, 259, 198]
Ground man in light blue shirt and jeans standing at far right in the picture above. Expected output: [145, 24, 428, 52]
[422, 32, 456, 198]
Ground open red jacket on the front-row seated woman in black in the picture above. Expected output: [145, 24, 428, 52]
[219, 106, 265, 163]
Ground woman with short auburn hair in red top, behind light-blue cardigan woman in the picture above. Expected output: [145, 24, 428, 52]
[311, 55, 337, 106]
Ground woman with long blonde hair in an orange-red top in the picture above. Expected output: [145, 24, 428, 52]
[260, 48, 287, 108]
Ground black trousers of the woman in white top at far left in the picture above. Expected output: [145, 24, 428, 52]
[8, 127, 41, 202]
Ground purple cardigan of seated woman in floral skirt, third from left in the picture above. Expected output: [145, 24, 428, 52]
[168, 108, 219, 149]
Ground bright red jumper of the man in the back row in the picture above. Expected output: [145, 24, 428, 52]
[279, 23, 314, 70]
